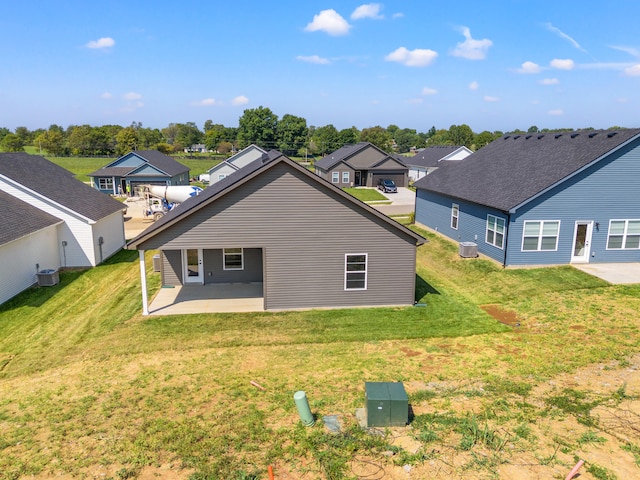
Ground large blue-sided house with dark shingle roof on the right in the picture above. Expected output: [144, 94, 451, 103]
[414, 129, 640, 266]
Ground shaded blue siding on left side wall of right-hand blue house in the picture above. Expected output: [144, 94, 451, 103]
[416, 189, 509, 263]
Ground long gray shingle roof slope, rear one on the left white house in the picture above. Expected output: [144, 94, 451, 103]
[0, 152, 123, 221]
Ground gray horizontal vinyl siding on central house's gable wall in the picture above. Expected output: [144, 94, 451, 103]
[138, 163, 416, 309]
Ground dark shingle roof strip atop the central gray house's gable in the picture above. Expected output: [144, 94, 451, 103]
[127, 150, 425, 249]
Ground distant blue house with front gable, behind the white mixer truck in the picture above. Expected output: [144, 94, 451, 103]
[89, 150, 189, 195]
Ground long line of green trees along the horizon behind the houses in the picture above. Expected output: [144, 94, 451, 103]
[0, 106, 588, 157]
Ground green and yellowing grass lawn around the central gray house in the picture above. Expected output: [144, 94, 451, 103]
[0, 231, 640, 480]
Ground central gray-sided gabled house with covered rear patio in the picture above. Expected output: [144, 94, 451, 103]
[127, 150, 425, 314]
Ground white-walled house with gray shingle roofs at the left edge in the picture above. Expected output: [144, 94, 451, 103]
[0, 153, 125, 303]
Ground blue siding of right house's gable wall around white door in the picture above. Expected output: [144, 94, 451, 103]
[507, 142, 640, 265]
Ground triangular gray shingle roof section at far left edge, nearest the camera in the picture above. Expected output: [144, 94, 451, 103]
[0, 190, 62, 245]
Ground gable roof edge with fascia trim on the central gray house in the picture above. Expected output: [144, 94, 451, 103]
[127, 150, 425, 249]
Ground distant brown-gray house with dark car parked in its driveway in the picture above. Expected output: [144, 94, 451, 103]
[315, 142, 409, 188]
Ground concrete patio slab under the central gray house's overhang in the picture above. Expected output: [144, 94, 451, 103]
[149, 282, 264, 315]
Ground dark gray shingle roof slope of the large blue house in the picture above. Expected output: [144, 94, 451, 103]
[414, 129, 640, 211]
